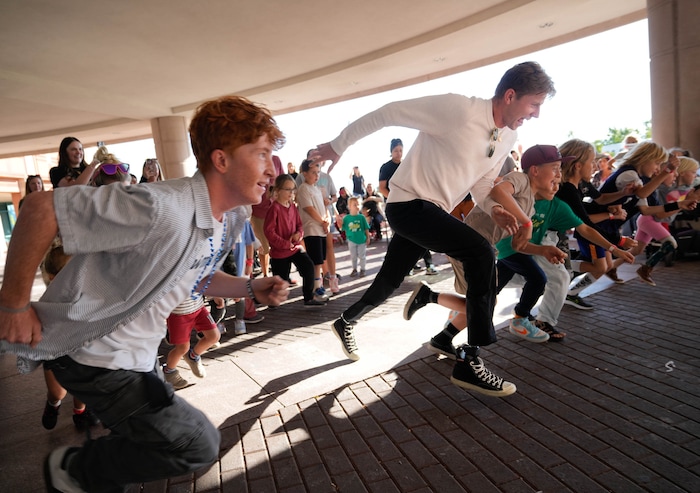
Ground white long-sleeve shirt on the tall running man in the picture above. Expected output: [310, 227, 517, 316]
[330, 94, 517, 212]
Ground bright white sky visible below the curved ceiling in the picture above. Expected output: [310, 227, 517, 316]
[85, 20, 651, 188]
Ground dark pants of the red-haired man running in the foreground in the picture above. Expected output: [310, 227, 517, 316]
[44, 356, 221, 493]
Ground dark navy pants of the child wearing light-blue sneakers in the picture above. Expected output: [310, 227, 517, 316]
[497, 253, 547, 317]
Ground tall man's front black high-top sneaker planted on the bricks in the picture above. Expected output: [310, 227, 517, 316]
[450, 345, 517, 397]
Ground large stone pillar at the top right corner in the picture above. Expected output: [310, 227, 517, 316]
[644, 0, 700, 158]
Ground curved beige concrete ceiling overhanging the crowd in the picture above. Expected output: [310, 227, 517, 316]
[0, 0, 646, 158]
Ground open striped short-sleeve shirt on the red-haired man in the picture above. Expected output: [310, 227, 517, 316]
[0, 172, 245, 373]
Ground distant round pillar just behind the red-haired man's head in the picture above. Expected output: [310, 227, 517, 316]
[151, 116, 190, 180]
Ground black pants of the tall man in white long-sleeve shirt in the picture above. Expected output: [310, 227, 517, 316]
[343, 200, 496, 346]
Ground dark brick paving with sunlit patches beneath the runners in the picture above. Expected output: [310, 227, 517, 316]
[129, 240, 700, 493]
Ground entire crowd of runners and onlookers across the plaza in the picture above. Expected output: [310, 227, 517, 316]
[0, 62, 699, 492]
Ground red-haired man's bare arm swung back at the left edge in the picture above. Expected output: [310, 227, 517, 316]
[0, 192, 58, 346]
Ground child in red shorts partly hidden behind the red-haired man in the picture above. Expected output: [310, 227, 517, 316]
[163, 296, 221, 390]
